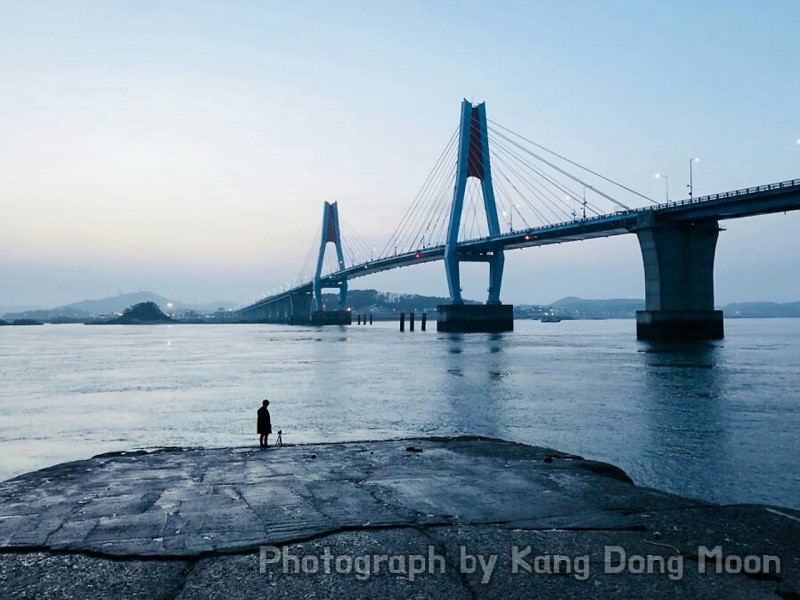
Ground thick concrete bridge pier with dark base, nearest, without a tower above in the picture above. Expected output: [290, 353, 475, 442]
[636, 214, 724, 340]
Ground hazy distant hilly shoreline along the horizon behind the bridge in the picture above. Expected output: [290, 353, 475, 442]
[0, 289, 800, 325]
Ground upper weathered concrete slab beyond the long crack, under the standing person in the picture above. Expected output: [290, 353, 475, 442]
[0, 439, 644, 556]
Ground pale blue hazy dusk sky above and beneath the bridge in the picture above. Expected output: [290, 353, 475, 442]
[0, 0, 800, 307]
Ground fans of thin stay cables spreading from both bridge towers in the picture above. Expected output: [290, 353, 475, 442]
[282, 114, 657, 292]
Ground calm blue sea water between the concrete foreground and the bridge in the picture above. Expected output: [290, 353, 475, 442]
[0, 319, 800, 508]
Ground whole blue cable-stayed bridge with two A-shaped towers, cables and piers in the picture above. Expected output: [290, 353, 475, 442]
[237, 100, 800, 338]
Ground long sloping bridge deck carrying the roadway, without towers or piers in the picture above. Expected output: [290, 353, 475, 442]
[238, 179, 800, 318]
